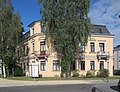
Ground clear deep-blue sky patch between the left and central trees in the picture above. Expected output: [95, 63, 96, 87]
[11, 0, 41, 31]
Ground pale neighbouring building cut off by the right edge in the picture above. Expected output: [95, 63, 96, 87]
[114, 45, 120, 70]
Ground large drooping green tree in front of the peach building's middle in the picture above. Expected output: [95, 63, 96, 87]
[38, 0, 91, 76]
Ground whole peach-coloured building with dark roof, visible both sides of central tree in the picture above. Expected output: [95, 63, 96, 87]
[18, 20, 114, 77]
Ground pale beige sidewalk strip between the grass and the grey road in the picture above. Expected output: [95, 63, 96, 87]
[0, 78, 90, 87]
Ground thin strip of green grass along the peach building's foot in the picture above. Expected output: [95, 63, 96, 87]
[3, 76, 120, 81]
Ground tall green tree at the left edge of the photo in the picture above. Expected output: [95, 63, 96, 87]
[0, 0, 23, 75]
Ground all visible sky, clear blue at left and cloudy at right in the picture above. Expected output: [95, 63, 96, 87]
[12, 0, 120, 46]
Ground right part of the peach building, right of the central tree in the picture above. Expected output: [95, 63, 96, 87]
[78, 25, 114, 76]
